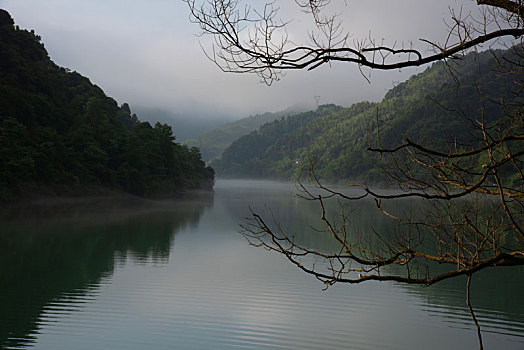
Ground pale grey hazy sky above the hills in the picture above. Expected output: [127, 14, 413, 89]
[0, 0, 484, 117]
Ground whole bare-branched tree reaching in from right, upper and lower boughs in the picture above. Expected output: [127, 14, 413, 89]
[185, 0, 524, 349]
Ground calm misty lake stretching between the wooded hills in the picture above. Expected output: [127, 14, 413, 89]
[0, 180, 524, 350]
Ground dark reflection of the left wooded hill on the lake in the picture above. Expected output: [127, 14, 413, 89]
[0, 197, 212, 348]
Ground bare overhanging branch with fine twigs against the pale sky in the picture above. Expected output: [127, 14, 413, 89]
[184, 0, 524, 84]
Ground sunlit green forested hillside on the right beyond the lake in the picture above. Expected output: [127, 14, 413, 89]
[211, 51, 521, 183]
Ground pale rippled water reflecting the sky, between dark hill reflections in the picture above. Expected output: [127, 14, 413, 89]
[0, 182, 524, 350]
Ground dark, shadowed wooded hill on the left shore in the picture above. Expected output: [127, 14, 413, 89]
[0, 10, 214, 199]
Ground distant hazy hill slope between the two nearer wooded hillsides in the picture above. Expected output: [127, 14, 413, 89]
[183, 108, 308, 162]
